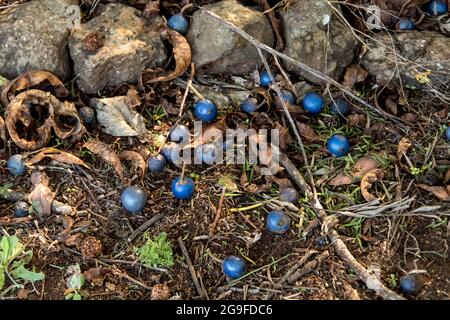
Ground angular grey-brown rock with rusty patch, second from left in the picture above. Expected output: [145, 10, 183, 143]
[69, 3, 167, 93]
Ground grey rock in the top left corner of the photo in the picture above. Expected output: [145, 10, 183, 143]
[0, 0, 78, 79]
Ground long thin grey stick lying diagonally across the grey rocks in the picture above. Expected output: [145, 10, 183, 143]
[200, 7, 404, 127]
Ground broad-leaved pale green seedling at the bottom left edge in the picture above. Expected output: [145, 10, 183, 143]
[0, 232, 44, 291]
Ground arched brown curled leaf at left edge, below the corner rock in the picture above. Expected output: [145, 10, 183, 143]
[1, 71, 69, 107]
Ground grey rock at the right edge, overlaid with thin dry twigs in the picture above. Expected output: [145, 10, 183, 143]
[361, 32, 450, 90]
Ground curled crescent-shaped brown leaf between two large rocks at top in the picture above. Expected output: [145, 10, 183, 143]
[147, 26, 192, 83]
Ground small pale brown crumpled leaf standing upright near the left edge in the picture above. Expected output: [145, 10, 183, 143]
[28, 171, 55, 216]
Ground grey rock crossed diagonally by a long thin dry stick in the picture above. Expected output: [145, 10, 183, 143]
[187, 0, 274, 74]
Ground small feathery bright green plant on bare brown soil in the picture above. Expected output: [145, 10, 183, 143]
[135, 232, 174, 268]
